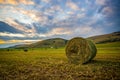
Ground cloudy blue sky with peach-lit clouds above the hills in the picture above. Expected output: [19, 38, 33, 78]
[0, 0, 120, 43]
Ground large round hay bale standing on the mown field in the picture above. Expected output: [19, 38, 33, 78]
[66, 37, 97, 64]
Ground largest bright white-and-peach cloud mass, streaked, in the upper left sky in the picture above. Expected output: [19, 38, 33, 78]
[0, 6, 45, 33]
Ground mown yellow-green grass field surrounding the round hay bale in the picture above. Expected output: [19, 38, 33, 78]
[0, 42, 120, 80]
